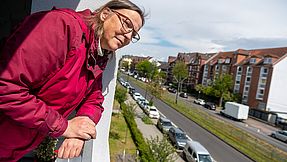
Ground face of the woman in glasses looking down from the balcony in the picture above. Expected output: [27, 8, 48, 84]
[100, 9, 142, 51]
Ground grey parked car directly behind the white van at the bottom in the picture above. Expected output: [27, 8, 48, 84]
[168, 127, 189, 150]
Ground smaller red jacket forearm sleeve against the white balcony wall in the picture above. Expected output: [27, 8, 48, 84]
[77, 74, 104, 124]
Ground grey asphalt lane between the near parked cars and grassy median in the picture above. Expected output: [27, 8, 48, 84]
[131, 83, 252, 162]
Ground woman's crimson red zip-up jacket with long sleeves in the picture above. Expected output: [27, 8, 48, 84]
[0, 10, 108, 162]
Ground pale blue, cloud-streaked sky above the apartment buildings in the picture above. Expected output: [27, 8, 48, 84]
[117, 0, 287, 61]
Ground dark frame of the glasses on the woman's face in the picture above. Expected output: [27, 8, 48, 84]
[111, 9, 140, 43]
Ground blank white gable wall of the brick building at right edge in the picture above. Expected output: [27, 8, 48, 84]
[266, 57, 287, 119]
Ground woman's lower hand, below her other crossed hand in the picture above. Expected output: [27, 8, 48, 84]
[58, 138, 85, 159]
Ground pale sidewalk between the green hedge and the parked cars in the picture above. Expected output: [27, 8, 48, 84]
[126, 95, 184, 162]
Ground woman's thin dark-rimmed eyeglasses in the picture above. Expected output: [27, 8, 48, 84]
[111, 10, 140, 43]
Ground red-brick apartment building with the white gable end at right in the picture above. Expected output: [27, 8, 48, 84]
[202, 47, 287, 119]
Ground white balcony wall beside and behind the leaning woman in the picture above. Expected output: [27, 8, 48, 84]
[31, 0, 116, 162]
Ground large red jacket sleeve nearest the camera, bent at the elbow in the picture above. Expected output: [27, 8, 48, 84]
[0, 12, 79, 137]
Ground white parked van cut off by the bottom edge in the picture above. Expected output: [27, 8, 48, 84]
[183, 141, 213, 162]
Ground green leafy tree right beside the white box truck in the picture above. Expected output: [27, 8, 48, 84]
[212, 74, 233, 107]
